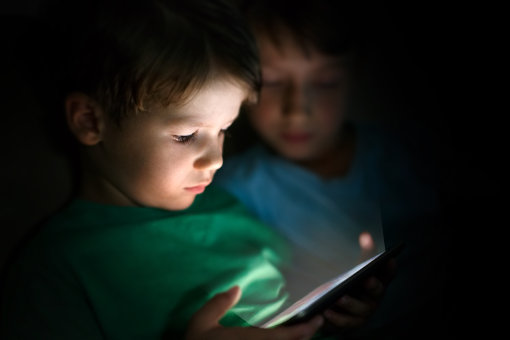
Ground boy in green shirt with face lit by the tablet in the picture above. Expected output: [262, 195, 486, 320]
[1, 1, 322, 340]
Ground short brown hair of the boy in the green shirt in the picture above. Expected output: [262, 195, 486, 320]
[43, 0, 260, 124]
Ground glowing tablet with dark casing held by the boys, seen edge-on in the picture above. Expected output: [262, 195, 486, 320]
[260, 243, 404, 328]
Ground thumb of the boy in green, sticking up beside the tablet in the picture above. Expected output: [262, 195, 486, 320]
[188, 286, 241, 333]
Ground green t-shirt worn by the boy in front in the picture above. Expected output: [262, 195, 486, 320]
[2, 187, 289, 339]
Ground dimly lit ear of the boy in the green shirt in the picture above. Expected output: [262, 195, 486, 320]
[65, 92, 105, 145]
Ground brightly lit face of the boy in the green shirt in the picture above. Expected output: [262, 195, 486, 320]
[92, 81, 247, 210]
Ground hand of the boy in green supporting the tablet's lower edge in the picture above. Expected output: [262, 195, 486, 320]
[186, 286, 324, 340]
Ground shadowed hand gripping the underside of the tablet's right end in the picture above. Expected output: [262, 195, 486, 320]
[324, 259, 396, 329]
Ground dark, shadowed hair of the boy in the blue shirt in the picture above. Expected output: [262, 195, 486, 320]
[234, 0, 358, 55]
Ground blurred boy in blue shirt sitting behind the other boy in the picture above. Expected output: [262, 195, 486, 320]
[215, 0, 437, 335]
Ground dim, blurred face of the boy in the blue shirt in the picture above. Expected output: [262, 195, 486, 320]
[250, 30, 347, 161]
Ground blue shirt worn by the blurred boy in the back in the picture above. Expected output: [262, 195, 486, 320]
[215, 122, 437, 332]
